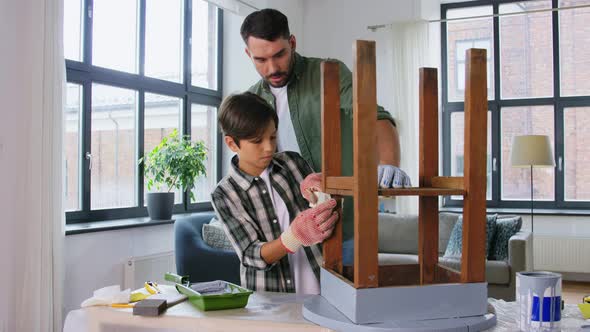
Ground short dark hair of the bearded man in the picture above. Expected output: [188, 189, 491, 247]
[240, 8, 291, 44]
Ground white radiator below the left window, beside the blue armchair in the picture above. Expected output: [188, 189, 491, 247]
[124, 251, 176, 289]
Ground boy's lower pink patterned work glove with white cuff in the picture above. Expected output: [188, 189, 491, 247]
[280, 199, 338, 253]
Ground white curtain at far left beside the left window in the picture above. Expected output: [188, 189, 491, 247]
[0, 0, 65, 332]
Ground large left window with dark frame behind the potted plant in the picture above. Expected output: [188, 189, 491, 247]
[64, 0, 222, 224]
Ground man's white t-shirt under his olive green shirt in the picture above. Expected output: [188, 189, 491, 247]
[270, 85, 301, 154]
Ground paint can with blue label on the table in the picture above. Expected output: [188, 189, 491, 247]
[516, 271, 561, 332]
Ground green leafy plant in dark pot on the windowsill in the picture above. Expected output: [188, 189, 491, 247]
[139, 129, 207, 220]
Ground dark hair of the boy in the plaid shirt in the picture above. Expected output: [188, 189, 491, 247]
[218, 92, 279, 147]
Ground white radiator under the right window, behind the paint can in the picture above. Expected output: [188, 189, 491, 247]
[533, 235, 590, 273]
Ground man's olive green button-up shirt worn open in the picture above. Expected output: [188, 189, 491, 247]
[249, 53, 395, 239]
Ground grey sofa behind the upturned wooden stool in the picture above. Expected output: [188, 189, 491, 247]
[379, 212, 532, 301]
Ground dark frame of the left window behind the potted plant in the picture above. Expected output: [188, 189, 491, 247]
[65, 0, 223, 225]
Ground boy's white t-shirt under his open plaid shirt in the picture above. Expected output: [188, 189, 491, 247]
[260, 168, 320, 294]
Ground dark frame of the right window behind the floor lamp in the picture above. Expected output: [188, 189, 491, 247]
[440, 0, 590, 210]
